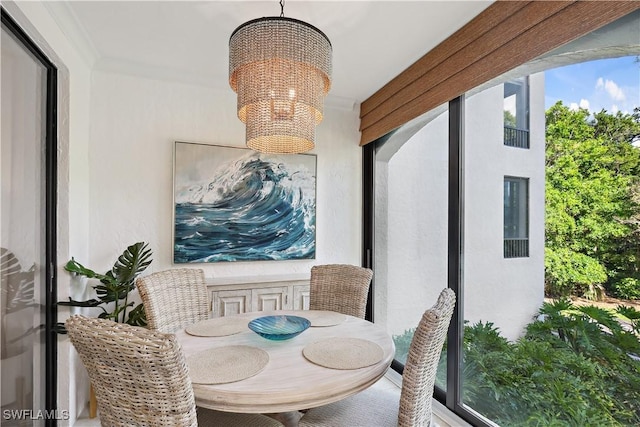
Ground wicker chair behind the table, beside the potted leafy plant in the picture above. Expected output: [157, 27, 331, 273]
[136, 268, 209, 333]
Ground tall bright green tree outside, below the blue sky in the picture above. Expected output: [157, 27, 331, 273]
[545, 102, 640, 296]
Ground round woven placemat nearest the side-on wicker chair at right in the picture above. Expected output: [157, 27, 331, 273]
[302, 338, 384, 369]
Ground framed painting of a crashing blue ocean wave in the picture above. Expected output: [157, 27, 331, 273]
[173, 142, 316, 264]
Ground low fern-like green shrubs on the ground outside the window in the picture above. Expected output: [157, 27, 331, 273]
[428, 299, 640, 427]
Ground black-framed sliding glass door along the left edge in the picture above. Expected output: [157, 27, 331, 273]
[0, 10, 56, 425]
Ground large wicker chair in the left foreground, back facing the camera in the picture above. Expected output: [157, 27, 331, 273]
[65, 315, 282, 427]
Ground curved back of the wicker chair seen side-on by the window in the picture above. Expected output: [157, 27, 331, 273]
[398, 288, 456, 427]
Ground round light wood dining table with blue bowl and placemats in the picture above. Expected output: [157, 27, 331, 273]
[176, 310, 395, 425]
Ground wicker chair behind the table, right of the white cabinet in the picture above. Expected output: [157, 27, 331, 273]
[309, 264, 373, 319]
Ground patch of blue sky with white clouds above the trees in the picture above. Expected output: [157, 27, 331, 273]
[545, 56, 640, 113]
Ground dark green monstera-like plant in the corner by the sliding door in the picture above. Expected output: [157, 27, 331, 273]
[57, 242, 152, 333]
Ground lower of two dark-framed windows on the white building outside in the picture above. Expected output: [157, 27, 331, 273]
[504, 176, 529, 258]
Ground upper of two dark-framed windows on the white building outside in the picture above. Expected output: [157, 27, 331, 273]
[504, 77, 529, 148]
